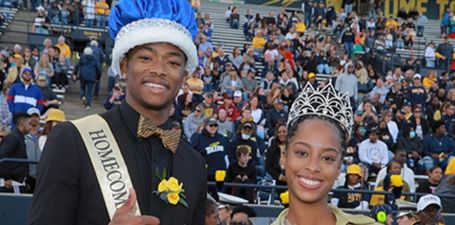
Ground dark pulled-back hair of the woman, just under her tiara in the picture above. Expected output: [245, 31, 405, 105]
[286, 116, 349, 155]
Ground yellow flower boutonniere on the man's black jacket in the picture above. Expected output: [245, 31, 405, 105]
[153, 170, 188, 207]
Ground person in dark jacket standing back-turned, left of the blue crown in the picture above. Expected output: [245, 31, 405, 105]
[74, 47, 101, 110]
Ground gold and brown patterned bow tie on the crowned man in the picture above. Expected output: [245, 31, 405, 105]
[137, 115, 181, 154]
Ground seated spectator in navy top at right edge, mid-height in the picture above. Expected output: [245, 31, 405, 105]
[423, 121, 455, 171]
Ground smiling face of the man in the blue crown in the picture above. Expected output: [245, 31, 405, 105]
[121, 43, 186, 111]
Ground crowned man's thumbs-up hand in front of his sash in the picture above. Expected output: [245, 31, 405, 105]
[109, 188, 160, 225]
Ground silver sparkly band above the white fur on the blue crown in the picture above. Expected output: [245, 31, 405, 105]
[115, 18, 193, 41]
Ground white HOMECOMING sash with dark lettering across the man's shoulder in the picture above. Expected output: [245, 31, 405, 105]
[72, 115, 141, 219]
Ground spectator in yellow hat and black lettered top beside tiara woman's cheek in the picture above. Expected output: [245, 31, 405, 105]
[330, 164, 370, 210]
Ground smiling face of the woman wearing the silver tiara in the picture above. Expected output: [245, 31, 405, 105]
[285, 119, 342, 204]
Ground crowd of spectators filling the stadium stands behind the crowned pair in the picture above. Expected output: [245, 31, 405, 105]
[0, 0, 455, 224]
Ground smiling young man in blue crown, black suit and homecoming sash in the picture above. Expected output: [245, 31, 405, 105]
[29, 0, 207, 225]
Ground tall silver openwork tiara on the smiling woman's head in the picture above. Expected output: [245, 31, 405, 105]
[287, 82, 354, 139]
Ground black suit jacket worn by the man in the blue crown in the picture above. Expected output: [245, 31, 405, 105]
[29, 103, 207, 225]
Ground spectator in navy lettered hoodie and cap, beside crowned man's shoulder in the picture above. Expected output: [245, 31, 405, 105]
[191, 118, 228, 198]
